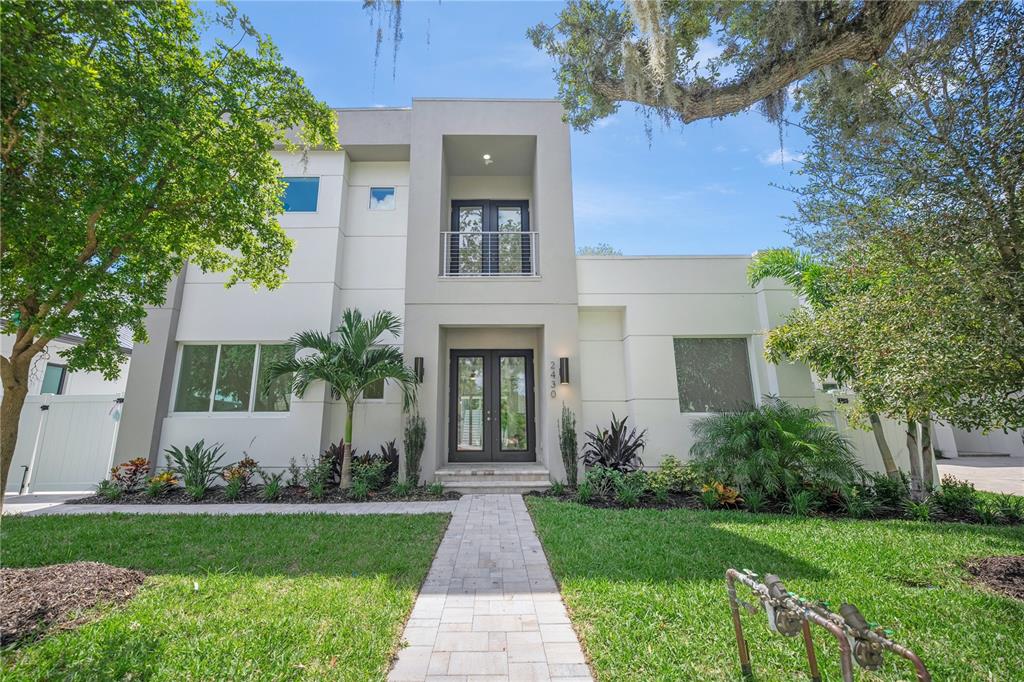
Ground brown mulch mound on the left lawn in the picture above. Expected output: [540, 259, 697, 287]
[0, 561, 145, 645]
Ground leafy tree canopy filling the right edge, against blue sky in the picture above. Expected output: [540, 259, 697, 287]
[773, 2, 1024, 428]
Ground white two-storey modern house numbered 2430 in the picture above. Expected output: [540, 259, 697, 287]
[108, 99, 1019, 480]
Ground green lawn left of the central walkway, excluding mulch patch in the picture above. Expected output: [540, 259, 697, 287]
[0, 514, 447, 682]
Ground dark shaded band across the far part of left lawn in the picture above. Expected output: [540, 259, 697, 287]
[2, 514, 447, 587]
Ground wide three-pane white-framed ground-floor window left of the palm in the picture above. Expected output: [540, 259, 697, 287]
[174, 343, 292, 413]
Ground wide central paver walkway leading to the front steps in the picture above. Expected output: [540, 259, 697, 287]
[388, 495, 593, 682]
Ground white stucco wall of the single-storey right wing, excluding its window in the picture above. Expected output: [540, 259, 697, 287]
[577, 256, 814, 466]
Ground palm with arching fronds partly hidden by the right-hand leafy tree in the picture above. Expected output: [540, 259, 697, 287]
[746, 249, 901, 479]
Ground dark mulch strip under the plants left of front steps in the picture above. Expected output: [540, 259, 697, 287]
[67, 485, 462, 505]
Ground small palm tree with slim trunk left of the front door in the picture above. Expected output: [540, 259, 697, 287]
[265, 308, 416, 488]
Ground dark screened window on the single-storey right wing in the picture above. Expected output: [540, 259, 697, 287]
[673, 339, 754, 412]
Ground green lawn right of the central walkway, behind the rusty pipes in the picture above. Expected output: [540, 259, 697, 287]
[527, 498, 1024, 681]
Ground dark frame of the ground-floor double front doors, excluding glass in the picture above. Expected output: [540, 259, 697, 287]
[447, 348, 537, 462]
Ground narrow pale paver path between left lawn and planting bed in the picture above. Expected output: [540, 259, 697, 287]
[25, 500, 458, 516]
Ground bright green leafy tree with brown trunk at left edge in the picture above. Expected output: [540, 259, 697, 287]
[0, 0, 337, 491]
